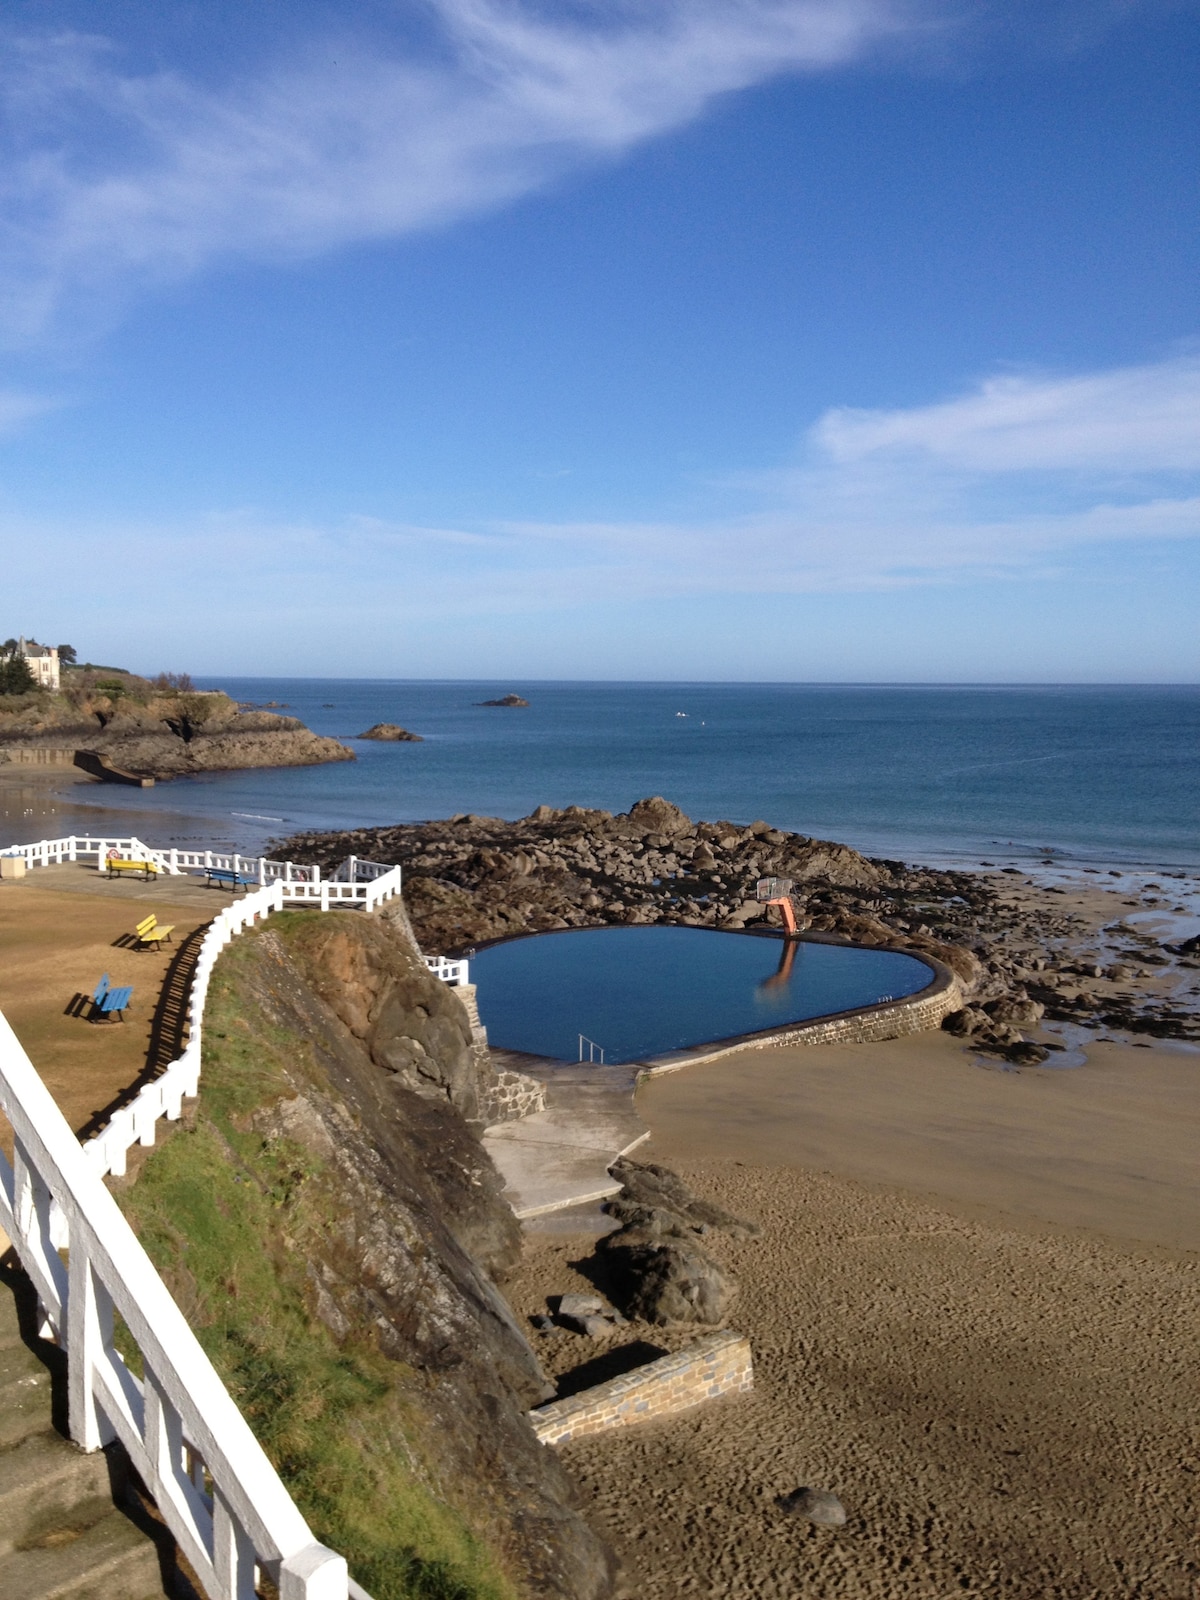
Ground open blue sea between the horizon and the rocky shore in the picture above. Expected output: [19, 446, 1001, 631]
[18, 678, 1200, 866]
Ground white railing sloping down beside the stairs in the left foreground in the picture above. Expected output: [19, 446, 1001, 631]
[0, 1013, 357, 1600]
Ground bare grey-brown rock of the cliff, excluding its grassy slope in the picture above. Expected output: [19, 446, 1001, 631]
[204, 915, 613, 1600]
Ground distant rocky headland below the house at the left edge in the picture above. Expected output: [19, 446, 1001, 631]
[0, 674, 354, 779]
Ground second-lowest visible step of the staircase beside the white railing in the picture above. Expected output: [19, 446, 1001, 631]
[0, 1432, 114, 1555]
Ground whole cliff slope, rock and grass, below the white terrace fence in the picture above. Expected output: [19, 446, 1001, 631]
[120, 914, 613, 1600]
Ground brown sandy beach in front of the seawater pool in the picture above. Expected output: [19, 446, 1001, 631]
[509, 1035, 1200, 1600]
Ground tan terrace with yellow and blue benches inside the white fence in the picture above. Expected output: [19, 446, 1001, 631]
[0, 862, 229, 1139]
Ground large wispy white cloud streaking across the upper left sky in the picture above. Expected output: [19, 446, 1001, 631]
[0, 0, 921, 334]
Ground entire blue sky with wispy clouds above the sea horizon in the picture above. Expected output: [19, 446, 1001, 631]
[0, 0, 1200, 682]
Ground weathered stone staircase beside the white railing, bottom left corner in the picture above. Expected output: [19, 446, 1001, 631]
[0, 1253, 178, 1600]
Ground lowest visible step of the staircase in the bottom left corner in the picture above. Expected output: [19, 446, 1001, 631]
[0, 1509, 163, 1600]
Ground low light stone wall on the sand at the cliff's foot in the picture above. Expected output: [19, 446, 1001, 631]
[530, 1331, 754, 1445]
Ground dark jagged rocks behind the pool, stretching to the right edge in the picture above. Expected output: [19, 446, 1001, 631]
[272, 797, 1200, 1062]
